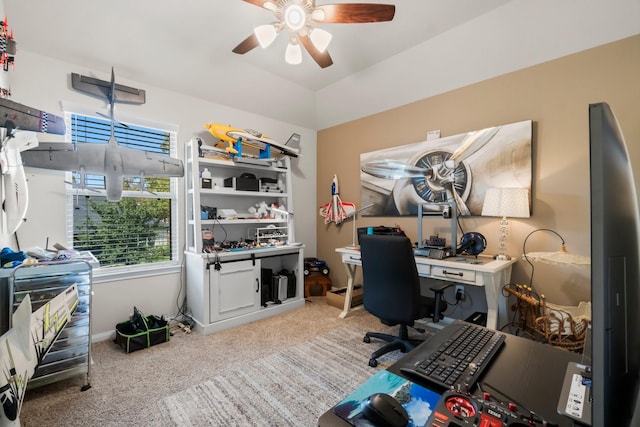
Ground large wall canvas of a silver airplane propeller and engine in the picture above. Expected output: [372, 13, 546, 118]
[360, 120, 532, 216]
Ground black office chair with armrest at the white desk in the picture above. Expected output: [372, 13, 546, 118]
[359, 234, 453, 367]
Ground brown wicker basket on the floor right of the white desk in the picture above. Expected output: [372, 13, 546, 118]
[504, 285, 590, 352]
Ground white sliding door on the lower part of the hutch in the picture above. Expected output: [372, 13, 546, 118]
[209, 260, 260, 322]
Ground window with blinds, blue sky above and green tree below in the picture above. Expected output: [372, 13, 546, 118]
[65, 113, 177, 269]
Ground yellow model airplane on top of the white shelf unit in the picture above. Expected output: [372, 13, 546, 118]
[204, 123, 300, 158]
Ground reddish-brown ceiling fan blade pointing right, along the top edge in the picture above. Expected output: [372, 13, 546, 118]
[312, 0, 396, 24]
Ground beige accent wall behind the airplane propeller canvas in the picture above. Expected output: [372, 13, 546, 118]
[317, 36, 640, 310]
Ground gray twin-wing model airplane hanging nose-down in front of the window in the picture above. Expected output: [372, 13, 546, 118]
[22, 68, 184, 201]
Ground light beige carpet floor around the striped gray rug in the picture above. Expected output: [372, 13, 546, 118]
[20, 297, 436, 427]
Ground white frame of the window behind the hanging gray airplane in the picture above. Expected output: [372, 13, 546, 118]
[63, 102, 181, 282]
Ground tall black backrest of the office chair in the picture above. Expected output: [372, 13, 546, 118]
[360, 234, 420, 324]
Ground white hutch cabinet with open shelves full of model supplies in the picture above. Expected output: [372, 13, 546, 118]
[185, 140, 304, 333]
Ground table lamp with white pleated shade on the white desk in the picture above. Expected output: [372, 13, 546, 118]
[482, 188, 530, 261]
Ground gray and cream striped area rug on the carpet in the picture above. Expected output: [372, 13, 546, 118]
[163, 327, 436, 427]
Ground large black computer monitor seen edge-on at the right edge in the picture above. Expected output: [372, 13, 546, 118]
[589, 103, 640, 427]
